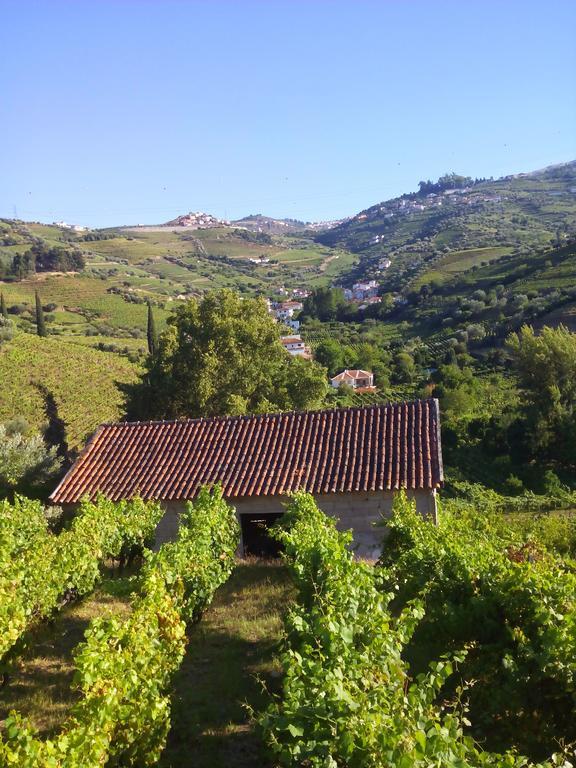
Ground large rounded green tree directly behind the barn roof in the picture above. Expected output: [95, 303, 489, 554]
[128, 289, 327, 418]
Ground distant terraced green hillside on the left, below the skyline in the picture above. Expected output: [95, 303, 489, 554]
[0, 220, 357, 354]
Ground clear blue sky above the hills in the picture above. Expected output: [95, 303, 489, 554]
[0, 0, 576, 227]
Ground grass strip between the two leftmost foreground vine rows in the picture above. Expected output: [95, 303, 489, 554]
[0, 572, 132, 738]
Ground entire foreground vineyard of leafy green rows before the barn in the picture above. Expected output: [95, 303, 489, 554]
[0, 489, 576, 768]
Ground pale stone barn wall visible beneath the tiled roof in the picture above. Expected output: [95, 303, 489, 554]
[156, 491, 436, 558]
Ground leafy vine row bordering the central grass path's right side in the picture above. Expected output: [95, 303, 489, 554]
[260, 493, 552, 768]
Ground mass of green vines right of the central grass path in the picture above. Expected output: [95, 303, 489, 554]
[260, 494, 576, 768]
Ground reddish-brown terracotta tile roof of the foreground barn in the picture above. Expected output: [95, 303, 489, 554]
[50, 399, 443, 504]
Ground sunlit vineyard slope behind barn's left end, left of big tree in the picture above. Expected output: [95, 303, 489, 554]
[0, 333, 138, 452]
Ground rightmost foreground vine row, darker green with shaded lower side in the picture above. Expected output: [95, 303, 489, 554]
[381, 497, 576, 758]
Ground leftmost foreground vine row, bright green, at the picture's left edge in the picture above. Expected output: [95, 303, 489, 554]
[0, 497, 162, 662]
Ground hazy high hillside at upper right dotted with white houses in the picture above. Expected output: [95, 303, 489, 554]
[317, 161, 576, 290]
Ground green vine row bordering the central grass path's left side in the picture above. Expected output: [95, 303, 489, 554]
[0, 489, 238, 768]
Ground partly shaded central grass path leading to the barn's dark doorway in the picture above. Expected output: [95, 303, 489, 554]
[159, 561, 292, 768]
